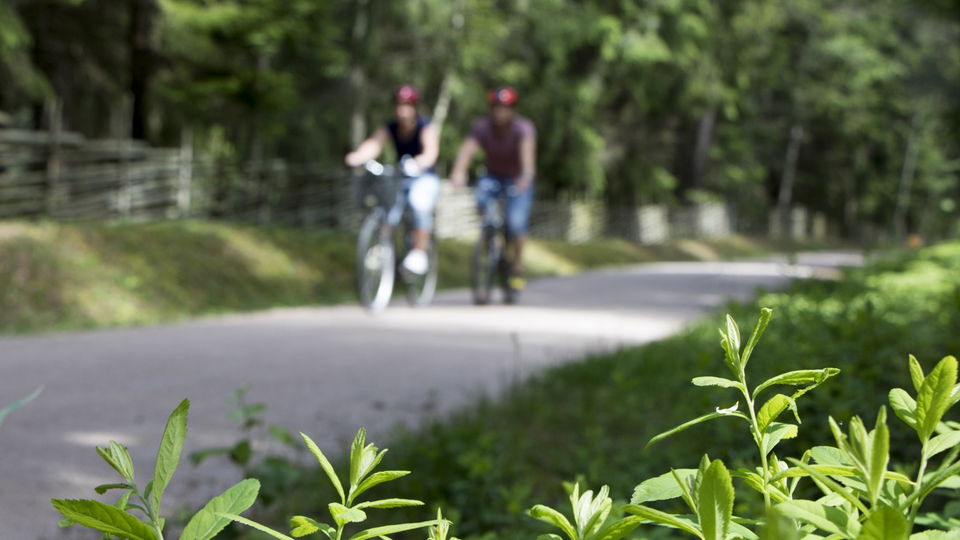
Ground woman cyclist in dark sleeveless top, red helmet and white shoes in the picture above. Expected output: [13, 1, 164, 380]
[344, 84, 440, 274]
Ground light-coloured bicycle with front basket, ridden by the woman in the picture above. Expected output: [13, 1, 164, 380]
[357, 161, 437, 312]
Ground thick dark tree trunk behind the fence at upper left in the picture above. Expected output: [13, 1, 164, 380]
[127, 0, 157, 140]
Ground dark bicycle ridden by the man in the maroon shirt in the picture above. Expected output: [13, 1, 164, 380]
[470, 194, 520, 306]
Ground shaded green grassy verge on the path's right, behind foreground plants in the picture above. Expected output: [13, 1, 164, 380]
[255, 243, 960, 540]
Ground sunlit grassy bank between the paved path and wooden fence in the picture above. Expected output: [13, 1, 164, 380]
[0, 222, 812, 333]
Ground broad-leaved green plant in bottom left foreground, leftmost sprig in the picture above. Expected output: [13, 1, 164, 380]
[51, 400, 260, 540]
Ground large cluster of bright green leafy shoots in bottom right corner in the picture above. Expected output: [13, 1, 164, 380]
[624, 309, 960, 540]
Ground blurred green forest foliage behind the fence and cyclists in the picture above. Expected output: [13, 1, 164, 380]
[0, 0, 960, 235]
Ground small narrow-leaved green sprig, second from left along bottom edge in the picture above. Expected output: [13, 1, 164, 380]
[219, 428, 449, 540]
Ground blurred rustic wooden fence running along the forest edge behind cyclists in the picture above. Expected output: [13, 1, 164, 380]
[0, 130, 827, 243]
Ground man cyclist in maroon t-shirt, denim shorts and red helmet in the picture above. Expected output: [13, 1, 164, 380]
[450, 86, 537, 290]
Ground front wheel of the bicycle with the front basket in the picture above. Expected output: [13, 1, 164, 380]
[357, 208, 396, 311]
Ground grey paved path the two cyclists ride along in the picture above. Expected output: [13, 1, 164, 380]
[0, 253, 860, 540]
